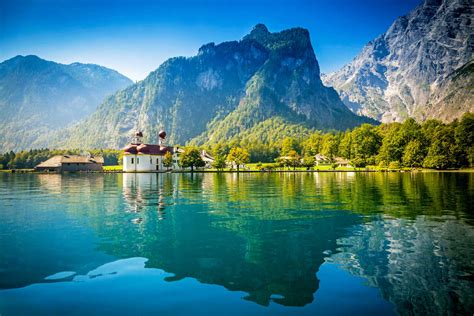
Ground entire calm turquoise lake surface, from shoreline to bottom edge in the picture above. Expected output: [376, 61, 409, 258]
[0, 173, 474, 316]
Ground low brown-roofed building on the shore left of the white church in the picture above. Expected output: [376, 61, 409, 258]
[35, 155, 104, 172]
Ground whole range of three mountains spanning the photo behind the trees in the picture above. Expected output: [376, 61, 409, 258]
[0, 0, 474, 151]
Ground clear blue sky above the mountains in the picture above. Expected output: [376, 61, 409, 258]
[0, 0, 421, 81]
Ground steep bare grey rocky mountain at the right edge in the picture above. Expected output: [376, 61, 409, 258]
[323, 0, 474, 122]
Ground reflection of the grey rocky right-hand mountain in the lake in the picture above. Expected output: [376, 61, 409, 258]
[331, 216, 474, 315]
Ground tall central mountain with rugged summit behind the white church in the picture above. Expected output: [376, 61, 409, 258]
[47, 24, 373, 148]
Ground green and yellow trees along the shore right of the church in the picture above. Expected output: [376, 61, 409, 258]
[206, 113, 474, 169]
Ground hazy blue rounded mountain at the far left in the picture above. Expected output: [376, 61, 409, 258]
[0, 56, 132, 152]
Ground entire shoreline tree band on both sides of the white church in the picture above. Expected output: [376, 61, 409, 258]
[0, 113, 474, 169]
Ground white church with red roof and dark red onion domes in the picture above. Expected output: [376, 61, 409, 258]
[123, 130, 180, 172]
